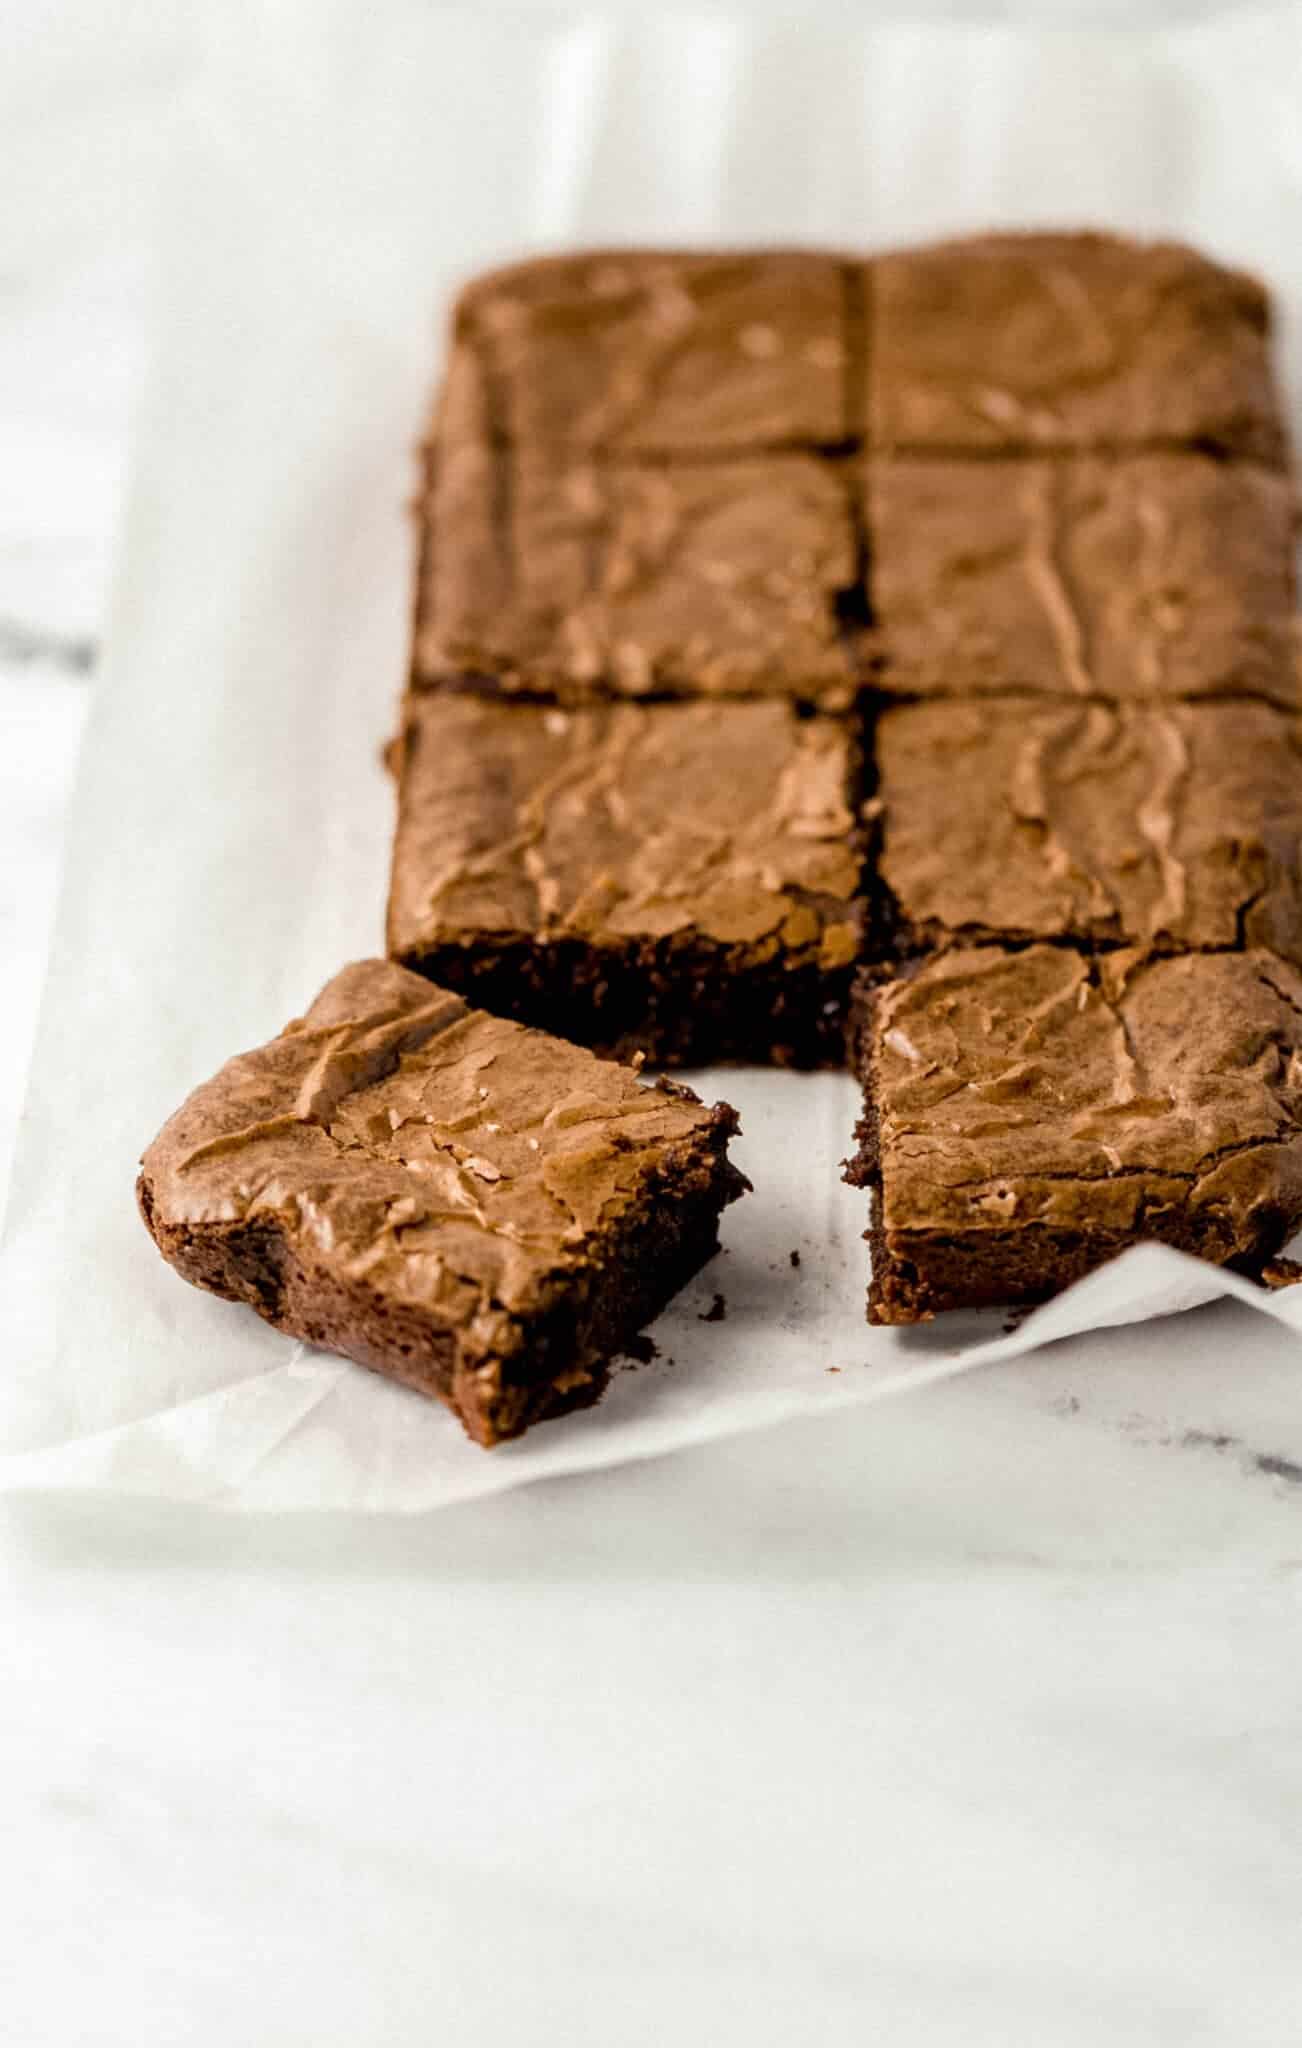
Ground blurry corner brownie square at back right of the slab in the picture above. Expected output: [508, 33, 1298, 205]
[866, 233, 1286, 465]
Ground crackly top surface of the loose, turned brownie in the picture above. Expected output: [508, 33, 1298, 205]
[143, 961, 731, 1354]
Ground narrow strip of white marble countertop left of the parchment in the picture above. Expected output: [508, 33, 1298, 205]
[0, 0, 192, 1200]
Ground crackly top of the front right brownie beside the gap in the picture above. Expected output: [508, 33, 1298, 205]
[872, 946, 1302, 1241]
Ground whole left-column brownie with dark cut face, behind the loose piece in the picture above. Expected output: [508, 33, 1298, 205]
[389, 690, 862, 1067]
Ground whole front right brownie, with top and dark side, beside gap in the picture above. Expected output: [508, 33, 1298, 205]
[848, 946, 1302, 1323]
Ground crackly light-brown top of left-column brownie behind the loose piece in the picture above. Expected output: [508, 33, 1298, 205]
[389, 690, 860, 967]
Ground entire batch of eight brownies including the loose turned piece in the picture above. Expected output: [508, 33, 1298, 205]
[141, 233, 1302, 1442]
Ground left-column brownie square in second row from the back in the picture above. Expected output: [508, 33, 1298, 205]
[414, 438, 858, 705]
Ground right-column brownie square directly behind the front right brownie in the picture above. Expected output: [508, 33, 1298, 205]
[876, 696, 1302, 965]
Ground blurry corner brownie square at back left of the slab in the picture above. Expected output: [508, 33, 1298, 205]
[454, 250, 854, 457]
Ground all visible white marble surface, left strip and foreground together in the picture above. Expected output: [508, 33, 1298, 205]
[0, 6, 1302, 2048]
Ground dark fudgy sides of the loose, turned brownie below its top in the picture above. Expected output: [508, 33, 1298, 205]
[135, 1081, 749, 1448]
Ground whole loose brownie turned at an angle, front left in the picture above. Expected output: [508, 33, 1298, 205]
[137, 961, 745, 1446]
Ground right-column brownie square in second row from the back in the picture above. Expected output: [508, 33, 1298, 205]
[868, 455, 1298, 707]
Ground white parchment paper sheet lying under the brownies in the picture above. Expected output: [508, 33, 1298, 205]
[0, 0, 1302, 1509]
